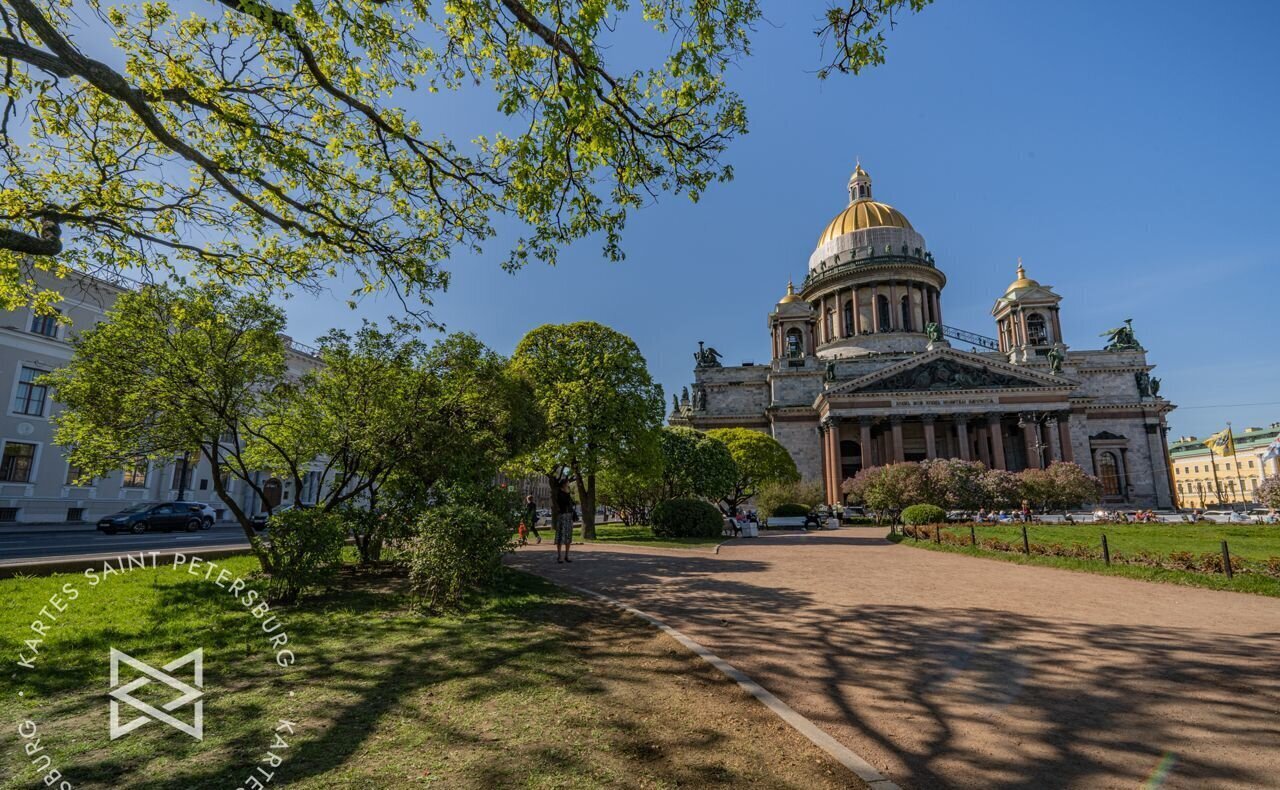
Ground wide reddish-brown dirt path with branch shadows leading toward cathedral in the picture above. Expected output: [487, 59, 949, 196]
[512, 529, 1280, 789]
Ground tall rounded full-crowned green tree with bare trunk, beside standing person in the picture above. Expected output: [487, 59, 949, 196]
[511, 321, 663, 540]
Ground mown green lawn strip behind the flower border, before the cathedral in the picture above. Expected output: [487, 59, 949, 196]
[960, 524, 1280, 560]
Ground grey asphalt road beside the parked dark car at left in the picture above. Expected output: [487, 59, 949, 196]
[0, 524, 248, 565]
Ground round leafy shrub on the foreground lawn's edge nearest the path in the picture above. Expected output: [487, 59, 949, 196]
[408, 504, 515, 612]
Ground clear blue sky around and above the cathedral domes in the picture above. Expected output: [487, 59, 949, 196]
[280, 0, 1280, 437]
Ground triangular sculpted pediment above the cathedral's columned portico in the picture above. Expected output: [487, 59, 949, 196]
[827, 348, 1071, 397]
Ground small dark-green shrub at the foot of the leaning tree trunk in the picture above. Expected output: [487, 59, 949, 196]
[257, 507, 347, 602]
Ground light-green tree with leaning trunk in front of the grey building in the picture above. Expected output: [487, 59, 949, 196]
[46, 280, 285, 563]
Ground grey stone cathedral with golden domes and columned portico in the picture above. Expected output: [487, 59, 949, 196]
[669, 164, 1174, 507]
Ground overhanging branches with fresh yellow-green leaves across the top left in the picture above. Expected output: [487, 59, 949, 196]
[0, 0, 923, 307]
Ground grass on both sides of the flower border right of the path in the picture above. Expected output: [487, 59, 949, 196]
[890, 524, 1280, 598]
